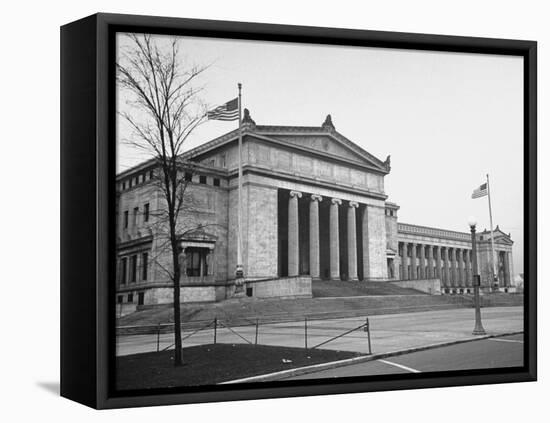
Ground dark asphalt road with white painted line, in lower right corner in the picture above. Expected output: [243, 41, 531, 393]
[285, 335, 523, 380]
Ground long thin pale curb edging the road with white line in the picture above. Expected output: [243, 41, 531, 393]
[219, 330, 523, 385]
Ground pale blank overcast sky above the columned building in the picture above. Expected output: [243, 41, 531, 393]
[118, 36, 523, 274]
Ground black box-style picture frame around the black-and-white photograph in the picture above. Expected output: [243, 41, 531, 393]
[61, 14, 537, 409]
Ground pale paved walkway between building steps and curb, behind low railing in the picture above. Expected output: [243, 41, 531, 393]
[117, 307, 523, 355]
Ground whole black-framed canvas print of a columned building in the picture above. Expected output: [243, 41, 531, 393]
[61, 14, 537, 408]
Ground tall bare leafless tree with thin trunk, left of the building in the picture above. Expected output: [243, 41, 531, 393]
[116, 34, 208, 366]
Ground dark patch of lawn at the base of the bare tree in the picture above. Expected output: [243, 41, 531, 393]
[116, 344, 358, 390]
